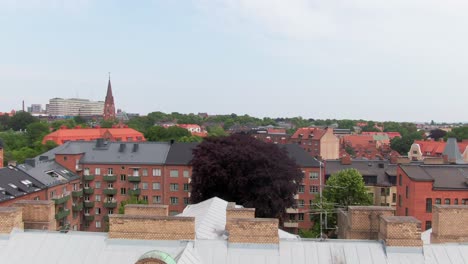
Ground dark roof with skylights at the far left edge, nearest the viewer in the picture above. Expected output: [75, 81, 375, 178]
[0, 166, 45, 202]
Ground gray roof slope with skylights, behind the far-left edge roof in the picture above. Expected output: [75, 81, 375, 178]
[18, 160, 80, 186]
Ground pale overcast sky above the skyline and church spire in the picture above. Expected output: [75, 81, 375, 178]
[0, 0, 468, 122]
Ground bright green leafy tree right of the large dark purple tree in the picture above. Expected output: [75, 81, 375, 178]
[323, 169, 372, 206]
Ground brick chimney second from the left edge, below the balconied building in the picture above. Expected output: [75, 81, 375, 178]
[12, 200, 57, 230]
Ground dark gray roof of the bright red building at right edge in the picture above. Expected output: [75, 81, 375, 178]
[400, 164, 468, 190]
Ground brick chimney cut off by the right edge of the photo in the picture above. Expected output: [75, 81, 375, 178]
[431, 205, 468, 243]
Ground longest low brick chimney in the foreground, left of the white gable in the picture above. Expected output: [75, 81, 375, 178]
[109, 215, 195, 240]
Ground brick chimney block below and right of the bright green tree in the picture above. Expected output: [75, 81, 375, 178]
[338, 206, 395, 240]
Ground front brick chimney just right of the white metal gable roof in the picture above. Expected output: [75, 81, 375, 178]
[226, 218, 279, 244]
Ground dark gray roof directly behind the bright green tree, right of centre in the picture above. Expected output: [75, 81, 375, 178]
[325, 160, 397, 186]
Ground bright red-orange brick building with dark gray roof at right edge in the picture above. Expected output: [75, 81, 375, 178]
[396, 163, 468, 230]
